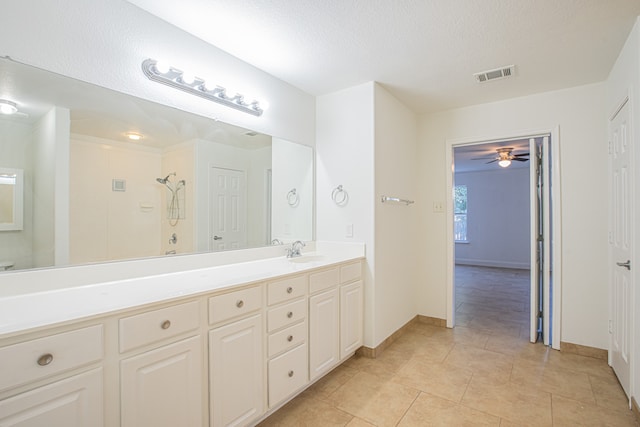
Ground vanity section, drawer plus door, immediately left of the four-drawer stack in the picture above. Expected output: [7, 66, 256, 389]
[209, 286, 264, 427]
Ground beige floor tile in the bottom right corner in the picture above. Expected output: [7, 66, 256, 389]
[553, 395, 638, 427]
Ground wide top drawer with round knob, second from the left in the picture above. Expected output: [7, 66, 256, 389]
[120, 301, 200, 353]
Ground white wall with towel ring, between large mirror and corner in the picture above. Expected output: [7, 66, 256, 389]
[316, 83, 376, 347]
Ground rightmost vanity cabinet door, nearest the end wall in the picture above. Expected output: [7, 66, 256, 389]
[340, 280, 364, 359]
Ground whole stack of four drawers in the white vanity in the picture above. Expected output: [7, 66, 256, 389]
[267, 275, 309, 408]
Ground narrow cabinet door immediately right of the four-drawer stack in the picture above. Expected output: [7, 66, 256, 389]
[309, 288, 340, 380]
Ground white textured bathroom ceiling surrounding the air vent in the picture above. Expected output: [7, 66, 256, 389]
[129, 0, 640, 113]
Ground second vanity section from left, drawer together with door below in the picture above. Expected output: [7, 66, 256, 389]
[119, 301, 204, 427]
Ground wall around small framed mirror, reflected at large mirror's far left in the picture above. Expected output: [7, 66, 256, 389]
[0, 119, 33, 269]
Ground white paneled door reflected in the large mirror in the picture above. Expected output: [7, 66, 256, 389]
[209, 167, 247, 251]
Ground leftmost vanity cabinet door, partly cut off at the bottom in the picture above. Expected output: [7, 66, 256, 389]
[0, 369, 103, 427]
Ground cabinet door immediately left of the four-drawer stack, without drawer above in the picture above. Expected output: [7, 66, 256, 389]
[209, 315, 264, 427]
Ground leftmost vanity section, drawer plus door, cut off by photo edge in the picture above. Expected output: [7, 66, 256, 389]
[0, 325, 104, 427]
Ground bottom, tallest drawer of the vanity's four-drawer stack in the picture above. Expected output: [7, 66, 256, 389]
[269, 344, 308, 407]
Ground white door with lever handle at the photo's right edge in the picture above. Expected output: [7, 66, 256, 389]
[609, 97, 632, 396]
